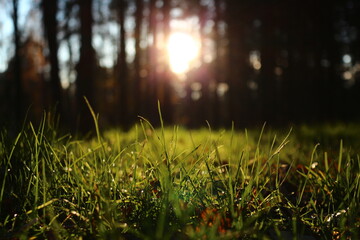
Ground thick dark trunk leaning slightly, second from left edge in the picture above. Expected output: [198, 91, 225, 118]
[42, 0, 63, 114]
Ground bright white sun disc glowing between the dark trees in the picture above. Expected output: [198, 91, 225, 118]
[167, 32, 199, 74]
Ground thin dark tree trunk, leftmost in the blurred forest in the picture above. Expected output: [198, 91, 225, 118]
[12, 0, 25, 127]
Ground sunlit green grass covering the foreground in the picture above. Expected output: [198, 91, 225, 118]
[0, 112, 360, 239]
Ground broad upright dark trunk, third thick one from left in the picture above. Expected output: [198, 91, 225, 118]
[76, 0, 96, 133]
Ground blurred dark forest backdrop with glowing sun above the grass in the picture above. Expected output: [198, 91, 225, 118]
[0, 0, 360, 132]
